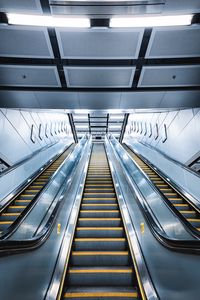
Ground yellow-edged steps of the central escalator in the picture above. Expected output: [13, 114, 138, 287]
[62, 143, 141, 300]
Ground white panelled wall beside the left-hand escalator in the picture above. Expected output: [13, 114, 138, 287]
[0, 109, 72, 165]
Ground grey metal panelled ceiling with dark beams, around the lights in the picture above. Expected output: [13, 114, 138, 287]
[0, 0, 200, 110]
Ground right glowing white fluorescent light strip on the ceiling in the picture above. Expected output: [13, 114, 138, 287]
[110, 15, 193, 27]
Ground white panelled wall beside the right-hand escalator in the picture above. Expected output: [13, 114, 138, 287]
[124, 108, 200, 164]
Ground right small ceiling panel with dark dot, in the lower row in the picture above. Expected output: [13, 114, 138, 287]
[138, 65, 200, 87]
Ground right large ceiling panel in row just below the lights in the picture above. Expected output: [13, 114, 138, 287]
[146, 26, 200, 58]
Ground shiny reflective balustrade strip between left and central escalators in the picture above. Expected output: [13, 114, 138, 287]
[10, 137, 87, 240]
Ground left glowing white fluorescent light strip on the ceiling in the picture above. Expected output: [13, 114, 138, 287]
[7, 13, 90, 28]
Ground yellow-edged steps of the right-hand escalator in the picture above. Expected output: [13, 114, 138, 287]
[123, 144, 200, 232]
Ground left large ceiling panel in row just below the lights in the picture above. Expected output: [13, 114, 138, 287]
[0, 26, 54, 58]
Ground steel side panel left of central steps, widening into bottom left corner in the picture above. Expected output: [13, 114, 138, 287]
[0, 137, 90, 300]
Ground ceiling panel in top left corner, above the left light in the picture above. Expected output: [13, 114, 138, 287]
[0, 0, 42, 13]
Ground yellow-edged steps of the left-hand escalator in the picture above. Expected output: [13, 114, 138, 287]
[0, 144, 74, 235]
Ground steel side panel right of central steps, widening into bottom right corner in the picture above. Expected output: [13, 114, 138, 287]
[104, 136, 200, 300]
